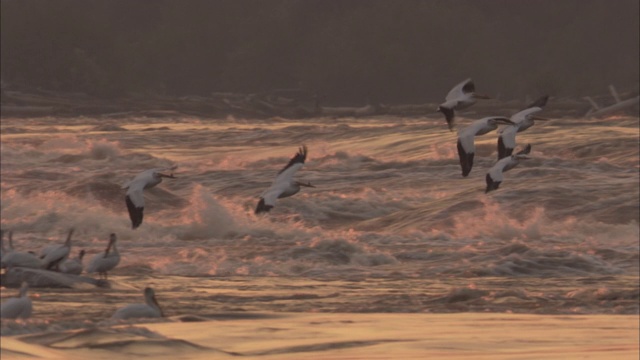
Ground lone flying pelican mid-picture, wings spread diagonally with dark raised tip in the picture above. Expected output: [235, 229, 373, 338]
[255, 145, 315, 214]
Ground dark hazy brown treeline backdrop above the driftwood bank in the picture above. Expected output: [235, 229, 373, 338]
[1, 0, 640, 103]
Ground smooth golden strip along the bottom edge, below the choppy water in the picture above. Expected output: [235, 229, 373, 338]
[1, 313, 640, 359]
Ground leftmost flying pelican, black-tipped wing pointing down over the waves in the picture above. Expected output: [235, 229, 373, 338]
[122, 166, 177, 229]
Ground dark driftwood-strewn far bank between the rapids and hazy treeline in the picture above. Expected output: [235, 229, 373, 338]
[0, 88, 638, 119]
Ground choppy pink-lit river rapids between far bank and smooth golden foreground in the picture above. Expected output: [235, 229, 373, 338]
[1, 117, 639, 334]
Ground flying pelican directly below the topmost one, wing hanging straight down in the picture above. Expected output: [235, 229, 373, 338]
[458, 116, 513, 176]
